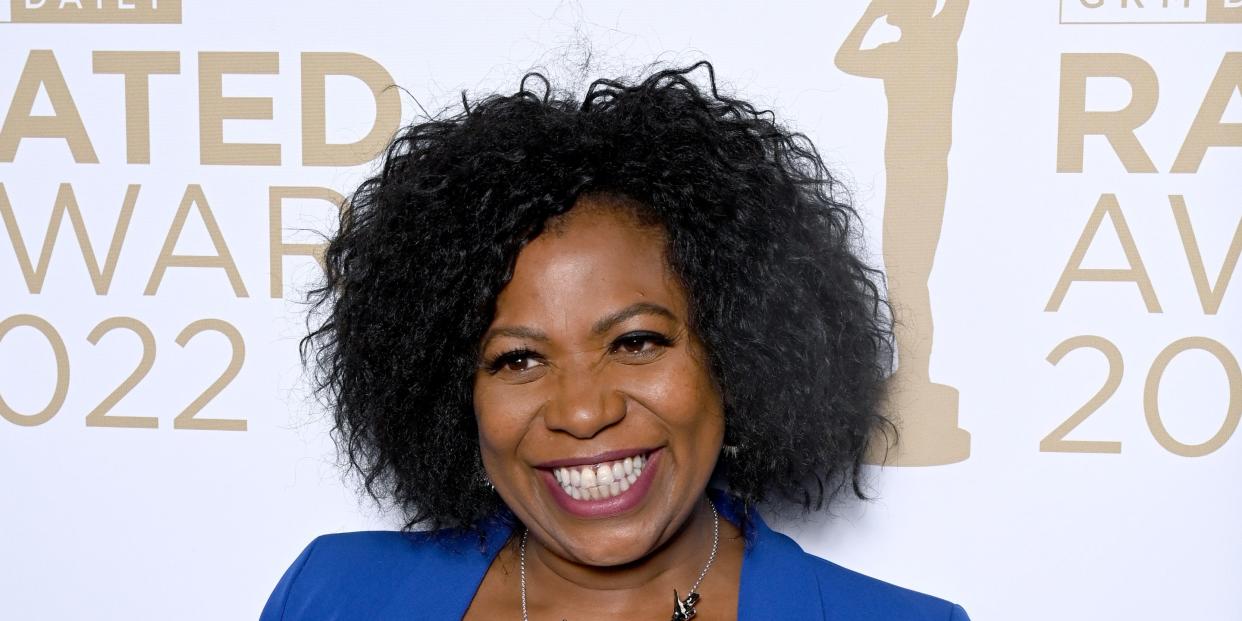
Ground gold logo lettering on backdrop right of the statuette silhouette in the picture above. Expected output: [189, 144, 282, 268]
[1040, 0, 1242, 457]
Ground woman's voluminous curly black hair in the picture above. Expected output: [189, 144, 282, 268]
[301, 62, 892, 528]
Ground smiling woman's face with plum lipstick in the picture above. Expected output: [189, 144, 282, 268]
[474, 197, 724, 566]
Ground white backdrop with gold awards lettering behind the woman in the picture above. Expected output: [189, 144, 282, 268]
[0, 0, 1242, 621]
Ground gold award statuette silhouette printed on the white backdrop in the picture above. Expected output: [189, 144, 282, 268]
[836, 0, 970, 466]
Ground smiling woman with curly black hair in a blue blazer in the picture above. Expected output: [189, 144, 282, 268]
[262, 63, 966, 621]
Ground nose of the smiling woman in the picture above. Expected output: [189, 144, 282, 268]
[544, 369, 626, 440]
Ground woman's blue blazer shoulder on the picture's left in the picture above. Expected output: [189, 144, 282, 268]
[260, 530, 494, 621]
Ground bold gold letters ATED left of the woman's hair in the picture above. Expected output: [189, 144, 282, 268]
[0, 50, 401, 166]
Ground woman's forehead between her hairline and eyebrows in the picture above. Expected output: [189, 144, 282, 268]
[494, 197, 686, 330]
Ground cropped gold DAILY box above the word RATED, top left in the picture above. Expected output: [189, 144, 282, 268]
[0, 0, 181, 24]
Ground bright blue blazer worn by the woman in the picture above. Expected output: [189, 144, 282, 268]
[260, 494, 969, 621]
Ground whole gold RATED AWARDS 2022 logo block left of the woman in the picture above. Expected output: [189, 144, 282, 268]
[0, 0, 401, 431]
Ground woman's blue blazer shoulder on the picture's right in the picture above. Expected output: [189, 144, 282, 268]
[753, 519, 968, 621]
